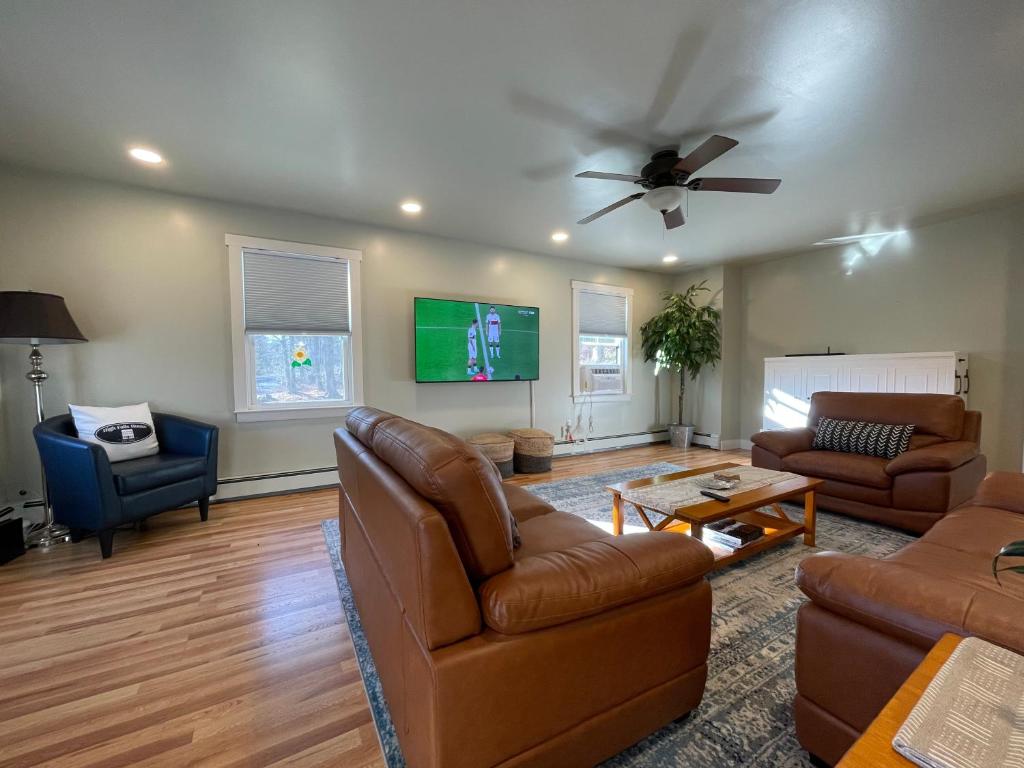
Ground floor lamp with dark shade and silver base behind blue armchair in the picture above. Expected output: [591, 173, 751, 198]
[0, 291, 87, 548]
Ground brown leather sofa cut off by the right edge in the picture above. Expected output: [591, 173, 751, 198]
[794, 472, 1024, 765]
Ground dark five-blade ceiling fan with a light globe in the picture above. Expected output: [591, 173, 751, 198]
[577, 134, 782, 229]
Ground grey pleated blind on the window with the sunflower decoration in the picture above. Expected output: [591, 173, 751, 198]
[242, 249, 352, 334]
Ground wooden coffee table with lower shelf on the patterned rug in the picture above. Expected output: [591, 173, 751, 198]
[606, 464, 824, 567]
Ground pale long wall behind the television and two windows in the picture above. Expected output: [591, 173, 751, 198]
[0, 167, 671, 499]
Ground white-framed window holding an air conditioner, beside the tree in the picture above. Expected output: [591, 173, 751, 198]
[572, 281, 633, 399]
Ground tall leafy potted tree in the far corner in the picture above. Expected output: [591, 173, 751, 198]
[640, 281, 722, 447]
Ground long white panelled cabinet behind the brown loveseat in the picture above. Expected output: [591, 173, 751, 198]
[762, 352, 971, 429]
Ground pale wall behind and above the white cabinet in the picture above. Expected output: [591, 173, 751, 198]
[741, 196, 1024, 471]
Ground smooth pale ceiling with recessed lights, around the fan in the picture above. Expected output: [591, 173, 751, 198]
[0, 0, 1024, 268]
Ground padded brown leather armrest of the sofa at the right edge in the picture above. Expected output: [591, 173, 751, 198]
[797, 552, 1024, 651]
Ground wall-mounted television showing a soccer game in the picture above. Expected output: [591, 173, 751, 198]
[413, 298, 541, 382]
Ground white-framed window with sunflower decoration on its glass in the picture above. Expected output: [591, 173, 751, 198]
[224, 234, 362, 421]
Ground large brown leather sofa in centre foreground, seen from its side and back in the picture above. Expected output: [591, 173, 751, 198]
[335, 408, 713, 768]
